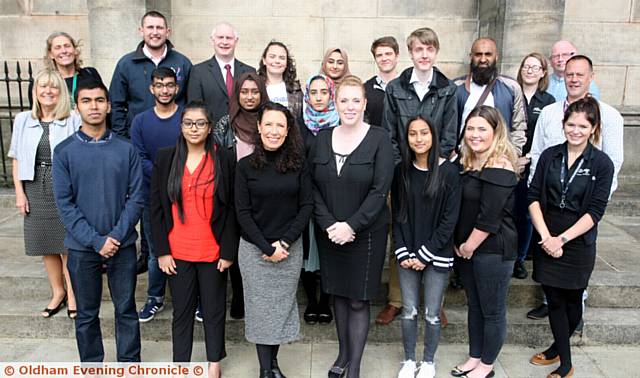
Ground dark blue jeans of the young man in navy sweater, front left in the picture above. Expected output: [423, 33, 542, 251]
[67, 245, 140, 362]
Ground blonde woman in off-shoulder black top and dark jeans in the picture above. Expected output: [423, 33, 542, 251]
[451, 105, 518, 378]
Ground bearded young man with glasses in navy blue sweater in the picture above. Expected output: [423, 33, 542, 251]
[131, 67, 182, 323]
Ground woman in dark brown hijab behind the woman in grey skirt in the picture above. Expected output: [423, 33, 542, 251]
[213, 72, 269, 161]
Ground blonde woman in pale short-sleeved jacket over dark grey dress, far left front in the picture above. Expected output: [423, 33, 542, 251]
[8, 69, 81, 319]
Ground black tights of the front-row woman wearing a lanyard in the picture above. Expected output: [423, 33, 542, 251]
[542, 285, 584, 377]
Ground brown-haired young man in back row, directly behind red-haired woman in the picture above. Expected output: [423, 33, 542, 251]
[364, 36, 400, 126]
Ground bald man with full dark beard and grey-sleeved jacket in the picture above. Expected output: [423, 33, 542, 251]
[455, 38, 527, 154]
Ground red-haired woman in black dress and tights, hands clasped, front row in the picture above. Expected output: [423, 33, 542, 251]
[311, 76, 393, 378]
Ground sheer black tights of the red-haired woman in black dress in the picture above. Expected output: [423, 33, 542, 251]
[333, 295, 370, 378]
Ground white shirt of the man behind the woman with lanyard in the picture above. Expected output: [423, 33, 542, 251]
[528, 100, 624, 194]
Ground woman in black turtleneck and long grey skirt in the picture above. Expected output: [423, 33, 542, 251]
[235, 102, 313, 378]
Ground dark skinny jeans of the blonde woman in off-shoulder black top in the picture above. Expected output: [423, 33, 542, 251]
[456, 253, 514, 365]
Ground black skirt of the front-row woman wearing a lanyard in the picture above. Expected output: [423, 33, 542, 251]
[533, 207, 596, 289]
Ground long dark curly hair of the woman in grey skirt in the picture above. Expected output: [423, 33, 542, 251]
[250, 101, 304, 173]
